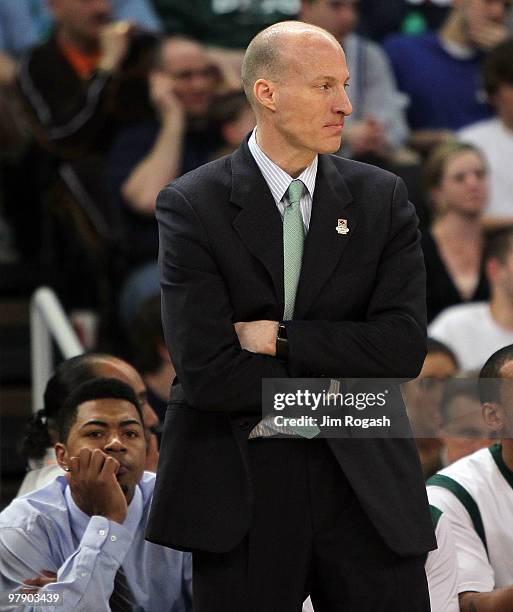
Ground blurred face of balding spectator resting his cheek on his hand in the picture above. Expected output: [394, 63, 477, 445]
[162, 41, 219, 117]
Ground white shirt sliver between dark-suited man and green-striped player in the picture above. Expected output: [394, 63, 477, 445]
[303, 508, 460, 612]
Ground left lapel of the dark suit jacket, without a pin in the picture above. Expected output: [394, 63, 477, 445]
[231, 142, 284, 312]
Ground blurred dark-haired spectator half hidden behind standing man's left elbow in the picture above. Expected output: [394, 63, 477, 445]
[130, 293, 176, 423]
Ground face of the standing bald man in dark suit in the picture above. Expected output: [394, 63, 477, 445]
[269, 35, 352, 158]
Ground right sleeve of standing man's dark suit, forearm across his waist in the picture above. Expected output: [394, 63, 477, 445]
[287, 179, 426, 378]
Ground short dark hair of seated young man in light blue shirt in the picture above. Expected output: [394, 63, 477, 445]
[57, 378, 143, 442]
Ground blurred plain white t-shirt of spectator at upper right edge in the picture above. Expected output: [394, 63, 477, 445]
[458, 118, 513, 217]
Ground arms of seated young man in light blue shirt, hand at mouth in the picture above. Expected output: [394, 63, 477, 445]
[0, 449, 133, 612]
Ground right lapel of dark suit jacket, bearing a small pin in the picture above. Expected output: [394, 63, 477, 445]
[294, 155, 358, 319]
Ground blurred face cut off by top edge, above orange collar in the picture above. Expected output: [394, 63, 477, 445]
[49, 0, 111, 43]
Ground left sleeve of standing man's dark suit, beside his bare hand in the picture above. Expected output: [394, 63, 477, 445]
[157, 187, 289, 414]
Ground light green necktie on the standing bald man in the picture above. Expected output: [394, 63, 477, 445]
[283, 180, 320, 438]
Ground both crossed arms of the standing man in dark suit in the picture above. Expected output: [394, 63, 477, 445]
[157, 175, 425, 413]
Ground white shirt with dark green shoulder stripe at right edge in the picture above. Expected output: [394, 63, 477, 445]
[427, 444, 513, 593]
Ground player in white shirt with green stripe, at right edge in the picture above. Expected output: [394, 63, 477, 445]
[428, 345, 513, 612]
